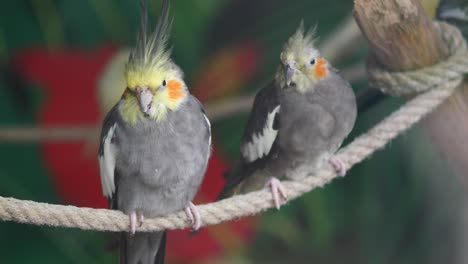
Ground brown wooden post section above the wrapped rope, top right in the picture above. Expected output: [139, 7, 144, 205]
[354, 0, 447, 71]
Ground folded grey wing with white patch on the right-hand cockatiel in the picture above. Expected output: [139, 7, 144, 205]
[241, 82, 281, 163]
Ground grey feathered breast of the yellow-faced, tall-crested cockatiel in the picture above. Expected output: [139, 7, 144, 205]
[99, 95, 211, 217]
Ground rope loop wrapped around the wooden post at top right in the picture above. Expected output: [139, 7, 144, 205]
[367, 21, 468, 96]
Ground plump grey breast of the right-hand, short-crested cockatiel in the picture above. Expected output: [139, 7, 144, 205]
[278, 71, 357, 164]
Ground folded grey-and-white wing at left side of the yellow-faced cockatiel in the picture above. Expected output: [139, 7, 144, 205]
[98, 107, 118, 200]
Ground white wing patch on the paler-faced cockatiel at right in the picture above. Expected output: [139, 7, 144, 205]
[241, 105, 280, 162]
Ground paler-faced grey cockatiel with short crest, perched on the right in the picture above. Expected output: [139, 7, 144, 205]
[219, 23, 357, 209]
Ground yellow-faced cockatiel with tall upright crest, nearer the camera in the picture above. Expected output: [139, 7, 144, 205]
[99, 0, 211, 264]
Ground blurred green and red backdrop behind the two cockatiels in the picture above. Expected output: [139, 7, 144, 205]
[0, 0, 468, 264]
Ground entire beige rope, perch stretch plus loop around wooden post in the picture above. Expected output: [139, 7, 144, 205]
[0, 23, 468, 232]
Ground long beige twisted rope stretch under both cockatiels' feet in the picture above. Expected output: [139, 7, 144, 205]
[0, 21, 468, 231]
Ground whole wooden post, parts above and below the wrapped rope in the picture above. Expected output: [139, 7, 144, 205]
[354, 0, 468, 187]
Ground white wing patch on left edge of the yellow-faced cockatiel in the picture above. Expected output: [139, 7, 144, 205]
[99, 124, 117, 198]
